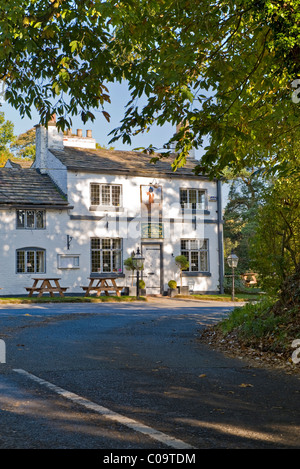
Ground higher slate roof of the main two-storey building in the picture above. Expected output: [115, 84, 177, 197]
[50, 147, 209, 179]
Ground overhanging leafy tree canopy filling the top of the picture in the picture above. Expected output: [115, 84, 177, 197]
[0, 0, 300, 177]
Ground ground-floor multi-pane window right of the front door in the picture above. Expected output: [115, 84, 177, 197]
[181, 239, 209, 272]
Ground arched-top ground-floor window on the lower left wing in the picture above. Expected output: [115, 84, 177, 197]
[17, 248, 46, 274]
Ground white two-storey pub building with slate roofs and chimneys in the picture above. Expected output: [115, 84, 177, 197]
[0, 122, 223, 296]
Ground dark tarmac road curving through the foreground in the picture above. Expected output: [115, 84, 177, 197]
[0, 299, 300, 452]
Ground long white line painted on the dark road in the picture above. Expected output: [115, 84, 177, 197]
[14, 369, 195, 449]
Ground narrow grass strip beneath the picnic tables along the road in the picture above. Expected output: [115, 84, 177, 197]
[0, 295, 147, 304]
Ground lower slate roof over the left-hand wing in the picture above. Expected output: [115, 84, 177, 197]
[0, 168, 69, 208]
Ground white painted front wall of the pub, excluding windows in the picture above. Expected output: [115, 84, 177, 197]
[0, 172, 219, 295]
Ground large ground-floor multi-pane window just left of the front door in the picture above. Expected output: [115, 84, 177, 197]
[91, 238, 122, 273]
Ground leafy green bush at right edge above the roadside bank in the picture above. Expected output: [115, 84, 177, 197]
[250, 178, 300, 291]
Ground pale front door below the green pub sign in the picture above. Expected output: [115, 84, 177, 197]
[143, 244, 161, 295]
